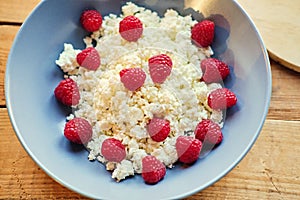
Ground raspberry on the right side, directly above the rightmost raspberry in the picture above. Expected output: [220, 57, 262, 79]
[201, 58, 230, 83]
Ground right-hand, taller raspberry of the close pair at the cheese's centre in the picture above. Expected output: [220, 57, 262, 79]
[148, 54, 173, 84]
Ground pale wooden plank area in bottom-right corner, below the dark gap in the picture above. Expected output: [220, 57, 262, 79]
[186, 120, 300, 200]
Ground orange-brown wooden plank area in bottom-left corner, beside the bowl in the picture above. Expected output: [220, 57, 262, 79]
[0, 108, 84, 199]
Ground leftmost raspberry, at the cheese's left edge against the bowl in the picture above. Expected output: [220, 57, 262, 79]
[54, 78, 80, 106]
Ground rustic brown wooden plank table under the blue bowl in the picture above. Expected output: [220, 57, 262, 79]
[0, 0, 300, 200]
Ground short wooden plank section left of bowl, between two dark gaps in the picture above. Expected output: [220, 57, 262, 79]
[0, 25, 20, 106]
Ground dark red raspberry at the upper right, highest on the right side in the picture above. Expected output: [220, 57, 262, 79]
[191, 20, 215, 47]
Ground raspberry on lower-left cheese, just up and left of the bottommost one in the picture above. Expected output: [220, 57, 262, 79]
[101, 138, 126, 162]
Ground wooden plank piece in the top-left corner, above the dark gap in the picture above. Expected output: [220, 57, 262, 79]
[0, 0, 40, 23]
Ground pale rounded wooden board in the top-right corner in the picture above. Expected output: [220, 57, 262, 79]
[237, 0, 300, 72]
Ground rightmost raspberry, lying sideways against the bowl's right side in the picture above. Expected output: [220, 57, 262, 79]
[207, 88, 237, 110]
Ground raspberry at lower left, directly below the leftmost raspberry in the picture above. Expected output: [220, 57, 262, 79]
[64, 118, 93, 144]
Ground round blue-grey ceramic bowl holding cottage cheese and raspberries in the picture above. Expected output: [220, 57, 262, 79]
[5, 0, 271, 200]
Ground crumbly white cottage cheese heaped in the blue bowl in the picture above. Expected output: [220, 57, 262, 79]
[56, 3, 223, 181]
